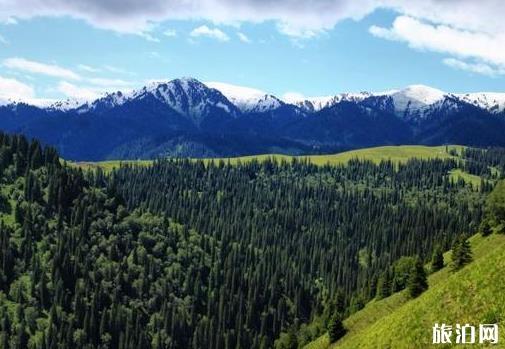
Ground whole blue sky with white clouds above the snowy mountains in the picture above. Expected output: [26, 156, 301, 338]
[0, 0, 505, 103]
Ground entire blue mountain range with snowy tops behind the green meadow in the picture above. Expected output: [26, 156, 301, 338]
[0, 78, 505, 161]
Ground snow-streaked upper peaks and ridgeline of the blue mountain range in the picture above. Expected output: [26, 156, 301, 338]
[5, 78, 505, 117]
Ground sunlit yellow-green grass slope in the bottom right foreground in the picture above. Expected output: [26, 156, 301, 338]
[305, 235, 505, 349]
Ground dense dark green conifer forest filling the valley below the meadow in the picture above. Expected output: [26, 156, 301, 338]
[0, 135, 502, 349]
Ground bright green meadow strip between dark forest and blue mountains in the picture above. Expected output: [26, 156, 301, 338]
[73, 145, 463, 171]
